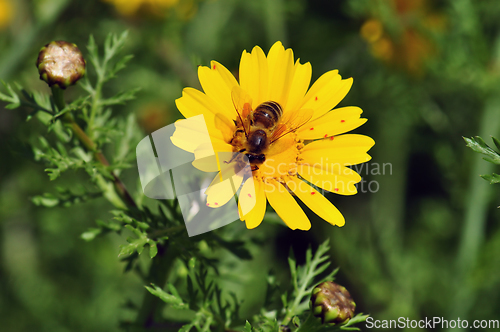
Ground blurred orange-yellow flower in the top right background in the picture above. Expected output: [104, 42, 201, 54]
[360, 0, 445, 75]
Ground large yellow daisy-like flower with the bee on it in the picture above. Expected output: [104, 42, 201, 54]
[172, 42, 375, 230]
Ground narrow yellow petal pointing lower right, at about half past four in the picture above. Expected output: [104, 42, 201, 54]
[286, 176, 345, 226]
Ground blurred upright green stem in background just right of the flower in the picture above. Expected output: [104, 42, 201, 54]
[371, 113, 414, 316]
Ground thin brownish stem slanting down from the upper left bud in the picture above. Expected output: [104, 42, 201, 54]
[51, 86, 137, 208]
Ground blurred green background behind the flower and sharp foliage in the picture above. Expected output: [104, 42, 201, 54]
[0, 0, 500, 331]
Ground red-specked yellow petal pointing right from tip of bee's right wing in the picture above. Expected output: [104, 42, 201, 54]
[297, 106, 366, 140]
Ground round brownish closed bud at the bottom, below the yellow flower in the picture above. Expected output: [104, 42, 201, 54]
[311, 281, 356, 324]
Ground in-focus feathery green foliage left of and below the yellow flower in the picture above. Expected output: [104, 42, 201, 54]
[0, 33, 365, 332]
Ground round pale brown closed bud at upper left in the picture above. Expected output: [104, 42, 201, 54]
[36, 40, 85, 89]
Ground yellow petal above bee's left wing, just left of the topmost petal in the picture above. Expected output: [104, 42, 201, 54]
[240, 46, 269, 108]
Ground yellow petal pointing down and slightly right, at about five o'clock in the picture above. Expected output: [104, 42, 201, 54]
[264, 180, 311, 231]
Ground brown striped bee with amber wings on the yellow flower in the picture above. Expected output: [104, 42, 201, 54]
[226, 87, 313, 171]
